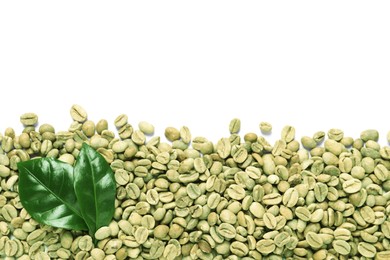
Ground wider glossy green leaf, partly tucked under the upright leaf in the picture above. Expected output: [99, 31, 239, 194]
[18, 158, 87, 230]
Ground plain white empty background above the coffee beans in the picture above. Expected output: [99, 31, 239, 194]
[0, 1, 390, 143]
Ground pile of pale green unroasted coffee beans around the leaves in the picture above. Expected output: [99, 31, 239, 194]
[0, 105, 390, 260]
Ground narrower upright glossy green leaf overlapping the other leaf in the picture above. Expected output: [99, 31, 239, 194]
[74, 143, 116, 235]
